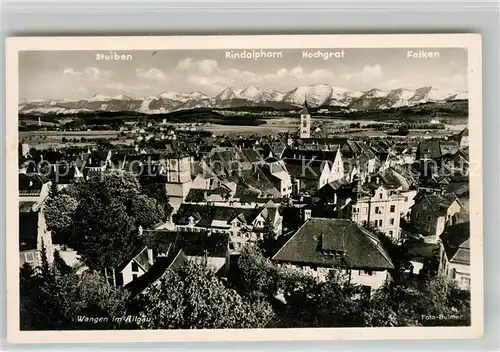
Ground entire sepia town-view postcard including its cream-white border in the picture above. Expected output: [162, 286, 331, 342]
[7, 35, 483, 342]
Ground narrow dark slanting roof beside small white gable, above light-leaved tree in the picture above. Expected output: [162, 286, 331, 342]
[124, 250, 187, 298]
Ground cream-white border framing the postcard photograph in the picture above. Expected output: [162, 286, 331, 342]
[5, 34, 484, 343]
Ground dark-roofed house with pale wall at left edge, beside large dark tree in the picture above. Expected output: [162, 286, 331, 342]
[19, 200, 54, 267]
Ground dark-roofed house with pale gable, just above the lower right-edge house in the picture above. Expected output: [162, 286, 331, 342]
[411, 193, 467, 242]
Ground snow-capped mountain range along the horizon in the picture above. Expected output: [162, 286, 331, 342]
[19, 84, 468, 114]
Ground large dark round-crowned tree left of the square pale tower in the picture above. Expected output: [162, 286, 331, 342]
[47, 174, 163, 269]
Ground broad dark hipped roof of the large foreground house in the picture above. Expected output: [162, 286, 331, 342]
[273, 218, 394, 270]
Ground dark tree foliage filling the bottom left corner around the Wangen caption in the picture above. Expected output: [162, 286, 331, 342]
[20, 268, 127, 330]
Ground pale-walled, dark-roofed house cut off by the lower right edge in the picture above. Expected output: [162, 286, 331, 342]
[439, 222, 470, 290]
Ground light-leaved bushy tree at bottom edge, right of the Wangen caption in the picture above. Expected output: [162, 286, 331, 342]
[140, 263, 273, 329]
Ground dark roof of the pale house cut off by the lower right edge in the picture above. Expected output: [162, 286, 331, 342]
[441, 222, 470, 265]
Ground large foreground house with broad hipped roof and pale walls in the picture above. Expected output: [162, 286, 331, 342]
[272, 218, 394, 291]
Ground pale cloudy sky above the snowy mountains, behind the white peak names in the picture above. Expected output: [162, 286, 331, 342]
[19, 48, 467, 100]
